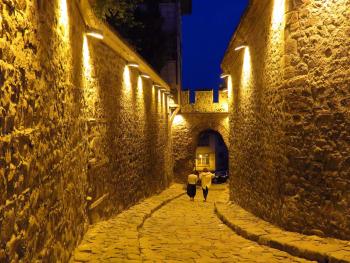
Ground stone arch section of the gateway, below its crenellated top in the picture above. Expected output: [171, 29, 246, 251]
[171, 113, 229, 182]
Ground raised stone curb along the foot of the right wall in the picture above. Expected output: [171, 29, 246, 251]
[214, 202, 350, 263]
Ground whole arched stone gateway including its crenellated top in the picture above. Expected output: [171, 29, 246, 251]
[172, 91, 229, 182]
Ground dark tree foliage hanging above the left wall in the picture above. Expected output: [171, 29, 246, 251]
[95, 0, 170, 72]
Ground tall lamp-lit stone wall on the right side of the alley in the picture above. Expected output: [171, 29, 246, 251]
[222, 0, 350, 239]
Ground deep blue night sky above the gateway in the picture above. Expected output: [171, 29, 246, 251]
[182, 0, 248, 89]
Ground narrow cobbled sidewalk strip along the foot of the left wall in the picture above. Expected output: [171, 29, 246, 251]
[71, 184, 184, 262]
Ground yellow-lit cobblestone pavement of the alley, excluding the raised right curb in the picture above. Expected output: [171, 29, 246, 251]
[73, 186, 310, 263]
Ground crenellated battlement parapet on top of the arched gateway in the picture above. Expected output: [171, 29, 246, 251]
[181, 90, 228, 113]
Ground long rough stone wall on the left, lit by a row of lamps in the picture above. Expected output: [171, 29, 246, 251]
[0, 0, 172, 262]
